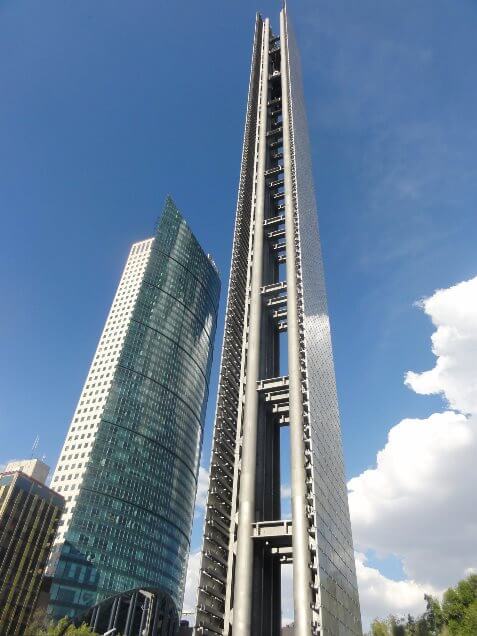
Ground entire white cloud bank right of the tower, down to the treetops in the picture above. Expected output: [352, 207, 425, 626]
[348, 278, 477, 625]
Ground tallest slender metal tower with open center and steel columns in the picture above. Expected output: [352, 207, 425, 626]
[196, 7, 361, 636]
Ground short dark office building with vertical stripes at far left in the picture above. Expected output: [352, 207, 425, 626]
[0, 460, 64, 636]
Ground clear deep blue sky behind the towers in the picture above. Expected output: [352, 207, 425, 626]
[0, 0, 477, 628]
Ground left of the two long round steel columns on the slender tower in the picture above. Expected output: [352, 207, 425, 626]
[233, 18, 270, 636]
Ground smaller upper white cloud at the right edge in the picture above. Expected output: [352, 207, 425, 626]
[406, 277, 477, 414]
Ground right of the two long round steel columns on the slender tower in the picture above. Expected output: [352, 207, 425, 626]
[280, 9, 312, 636]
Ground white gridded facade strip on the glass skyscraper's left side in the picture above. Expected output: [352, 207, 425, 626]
[50, 238, 154, 569]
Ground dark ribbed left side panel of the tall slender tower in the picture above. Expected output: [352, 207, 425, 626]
[196, 16, 263, 634]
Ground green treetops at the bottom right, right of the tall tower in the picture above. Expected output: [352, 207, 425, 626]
[369, 574, 477, 636]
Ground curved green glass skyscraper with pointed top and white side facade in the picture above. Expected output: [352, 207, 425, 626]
[49, 198, 220, 617]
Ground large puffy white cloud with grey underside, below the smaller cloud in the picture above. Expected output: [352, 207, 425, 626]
[348, 411, 477, 587]
